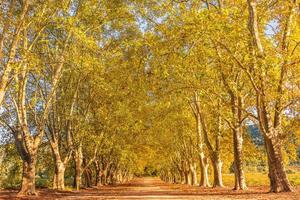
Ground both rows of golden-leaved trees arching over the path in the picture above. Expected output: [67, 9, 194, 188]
[0, 0, 300, 195]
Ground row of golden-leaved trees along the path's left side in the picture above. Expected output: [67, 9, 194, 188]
[0, 0, 152, 195]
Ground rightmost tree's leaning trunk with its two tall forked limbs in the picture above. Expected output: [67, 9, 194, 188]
[241, 0, 297, 192]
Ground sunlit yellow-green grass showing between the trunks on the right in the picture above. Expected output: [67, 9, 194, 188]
[223, 173, 300, 186]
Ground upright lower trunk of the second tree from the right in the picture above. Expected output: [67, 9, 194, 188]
[233, 127, 247, 190]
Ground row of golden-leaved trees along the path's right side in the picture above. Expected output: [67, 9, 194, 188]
[149, 0, 299, 192]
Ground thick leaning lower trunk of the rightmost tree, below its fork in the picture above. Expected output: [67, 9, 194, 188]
[265, 134, 292, 192]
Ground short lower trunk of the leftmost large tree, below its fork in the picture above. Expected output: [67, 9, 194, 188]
[18, 155, 37, 196]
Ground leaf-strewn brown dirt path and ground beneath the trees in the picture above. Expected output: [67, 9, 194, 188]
[0, 177, 300, 200]
